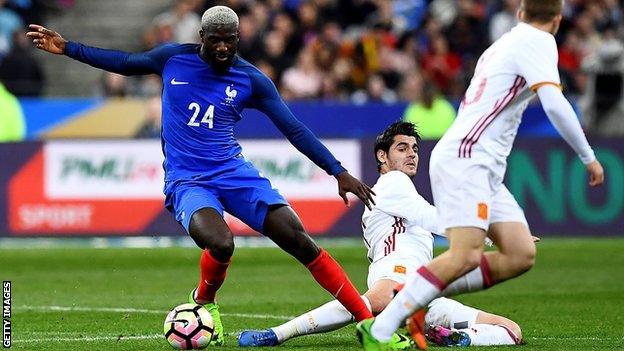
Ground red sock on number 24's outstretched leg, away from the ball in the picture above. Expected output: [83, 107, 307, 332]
[306, 248, 373, 322]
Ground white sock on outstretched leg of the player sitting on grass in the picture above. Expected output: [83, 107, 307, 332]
[271, 296, 371, 343]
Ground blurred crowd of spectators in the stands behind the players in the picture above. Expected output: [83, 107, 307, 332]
[0, 0, 624, 139]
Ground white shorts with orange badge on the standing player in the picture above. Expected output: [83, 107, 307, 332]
[429, 157, 528, 230]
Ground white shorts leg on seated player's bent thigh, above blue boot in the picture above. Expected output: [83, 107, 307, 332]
[425, 297, 481, 329]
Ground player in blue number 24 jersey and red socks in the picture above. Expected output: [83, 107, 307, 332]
[27, 6, 374, 345]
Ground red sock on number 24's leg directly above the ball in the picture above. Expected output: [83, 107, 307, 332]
[195, 249, 230, 303]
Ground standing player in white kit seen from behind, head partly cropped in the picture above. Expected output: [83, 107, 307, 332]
[358, 0, 604, 350]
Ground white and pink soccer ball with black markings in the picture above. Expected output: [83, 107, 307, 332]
[164, 303, 214, 350]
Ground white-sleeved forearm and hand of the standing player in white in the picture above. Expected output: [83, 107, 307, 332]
[537, 85, 604, 186]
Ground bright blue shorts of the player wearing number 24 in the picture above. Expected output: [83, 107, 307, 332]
[165, 160, 288, 233]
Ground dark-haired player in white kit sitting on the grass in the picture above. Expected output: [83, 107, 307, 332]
[239, 122, 522, 350]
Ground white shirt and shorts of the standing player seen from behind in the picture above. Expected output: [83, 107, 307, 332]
[429, 23, 560, 230]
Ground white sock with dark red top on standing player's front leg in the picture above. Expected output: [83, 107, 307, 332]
[371, 266, 445, 341]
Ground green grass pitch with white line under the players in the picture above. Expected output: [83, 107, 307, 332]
[0, 239, 624, 351]
